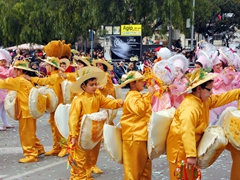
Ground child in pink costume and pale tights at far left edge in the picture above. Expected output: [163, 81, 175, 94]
[0, 49, 14, 131]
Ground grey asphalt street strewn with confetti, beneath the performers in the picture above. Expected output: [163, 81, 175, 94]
[0, 89, 232, 180]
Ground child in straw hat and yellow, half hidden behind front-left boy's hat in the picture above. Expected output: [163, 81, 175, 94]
[92, 59, 116, 98]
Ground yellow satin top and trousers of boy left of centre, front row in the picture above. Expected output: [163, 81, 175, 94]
[68, 92, 122, 180]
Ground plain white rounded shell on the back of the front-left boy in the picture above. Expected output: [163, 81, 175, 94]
[54, 104, 71, 139]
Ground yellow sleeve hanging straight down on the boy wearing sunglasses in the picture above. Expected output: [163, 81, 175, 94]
[179, 106, 199, 157]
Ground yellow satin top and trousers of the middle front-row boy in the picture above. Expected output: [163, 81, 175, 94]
[120, 91, 152, 180]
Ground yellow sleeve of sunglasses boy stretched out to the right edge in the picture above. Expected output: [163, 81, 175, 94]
[209, 89, 240, 109]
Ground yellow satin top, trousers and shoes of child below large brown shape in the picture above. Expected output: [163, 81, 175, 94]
[31, 70, 67, 157]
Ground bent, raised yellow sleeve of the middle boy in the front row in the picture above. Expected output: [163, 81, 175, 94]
[125, 93, 152, 115]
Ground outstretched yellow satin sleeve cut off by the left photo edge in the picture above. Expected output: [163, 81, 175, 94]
[0, 78, 20, 91]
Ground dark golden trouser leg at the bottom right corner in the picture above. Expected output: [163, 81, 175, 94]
[226, 143, 240, 180]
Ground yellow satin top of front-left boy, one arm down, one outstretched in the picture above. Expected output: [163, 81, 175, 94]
[68, 92, 122, 137]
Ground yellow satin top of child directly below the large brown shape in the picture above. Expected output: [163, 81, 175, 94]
[31, 70, 64, 104]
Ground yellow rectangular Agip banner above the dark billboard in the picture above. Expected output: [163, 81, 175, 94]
[121, 24, 142, 36]
